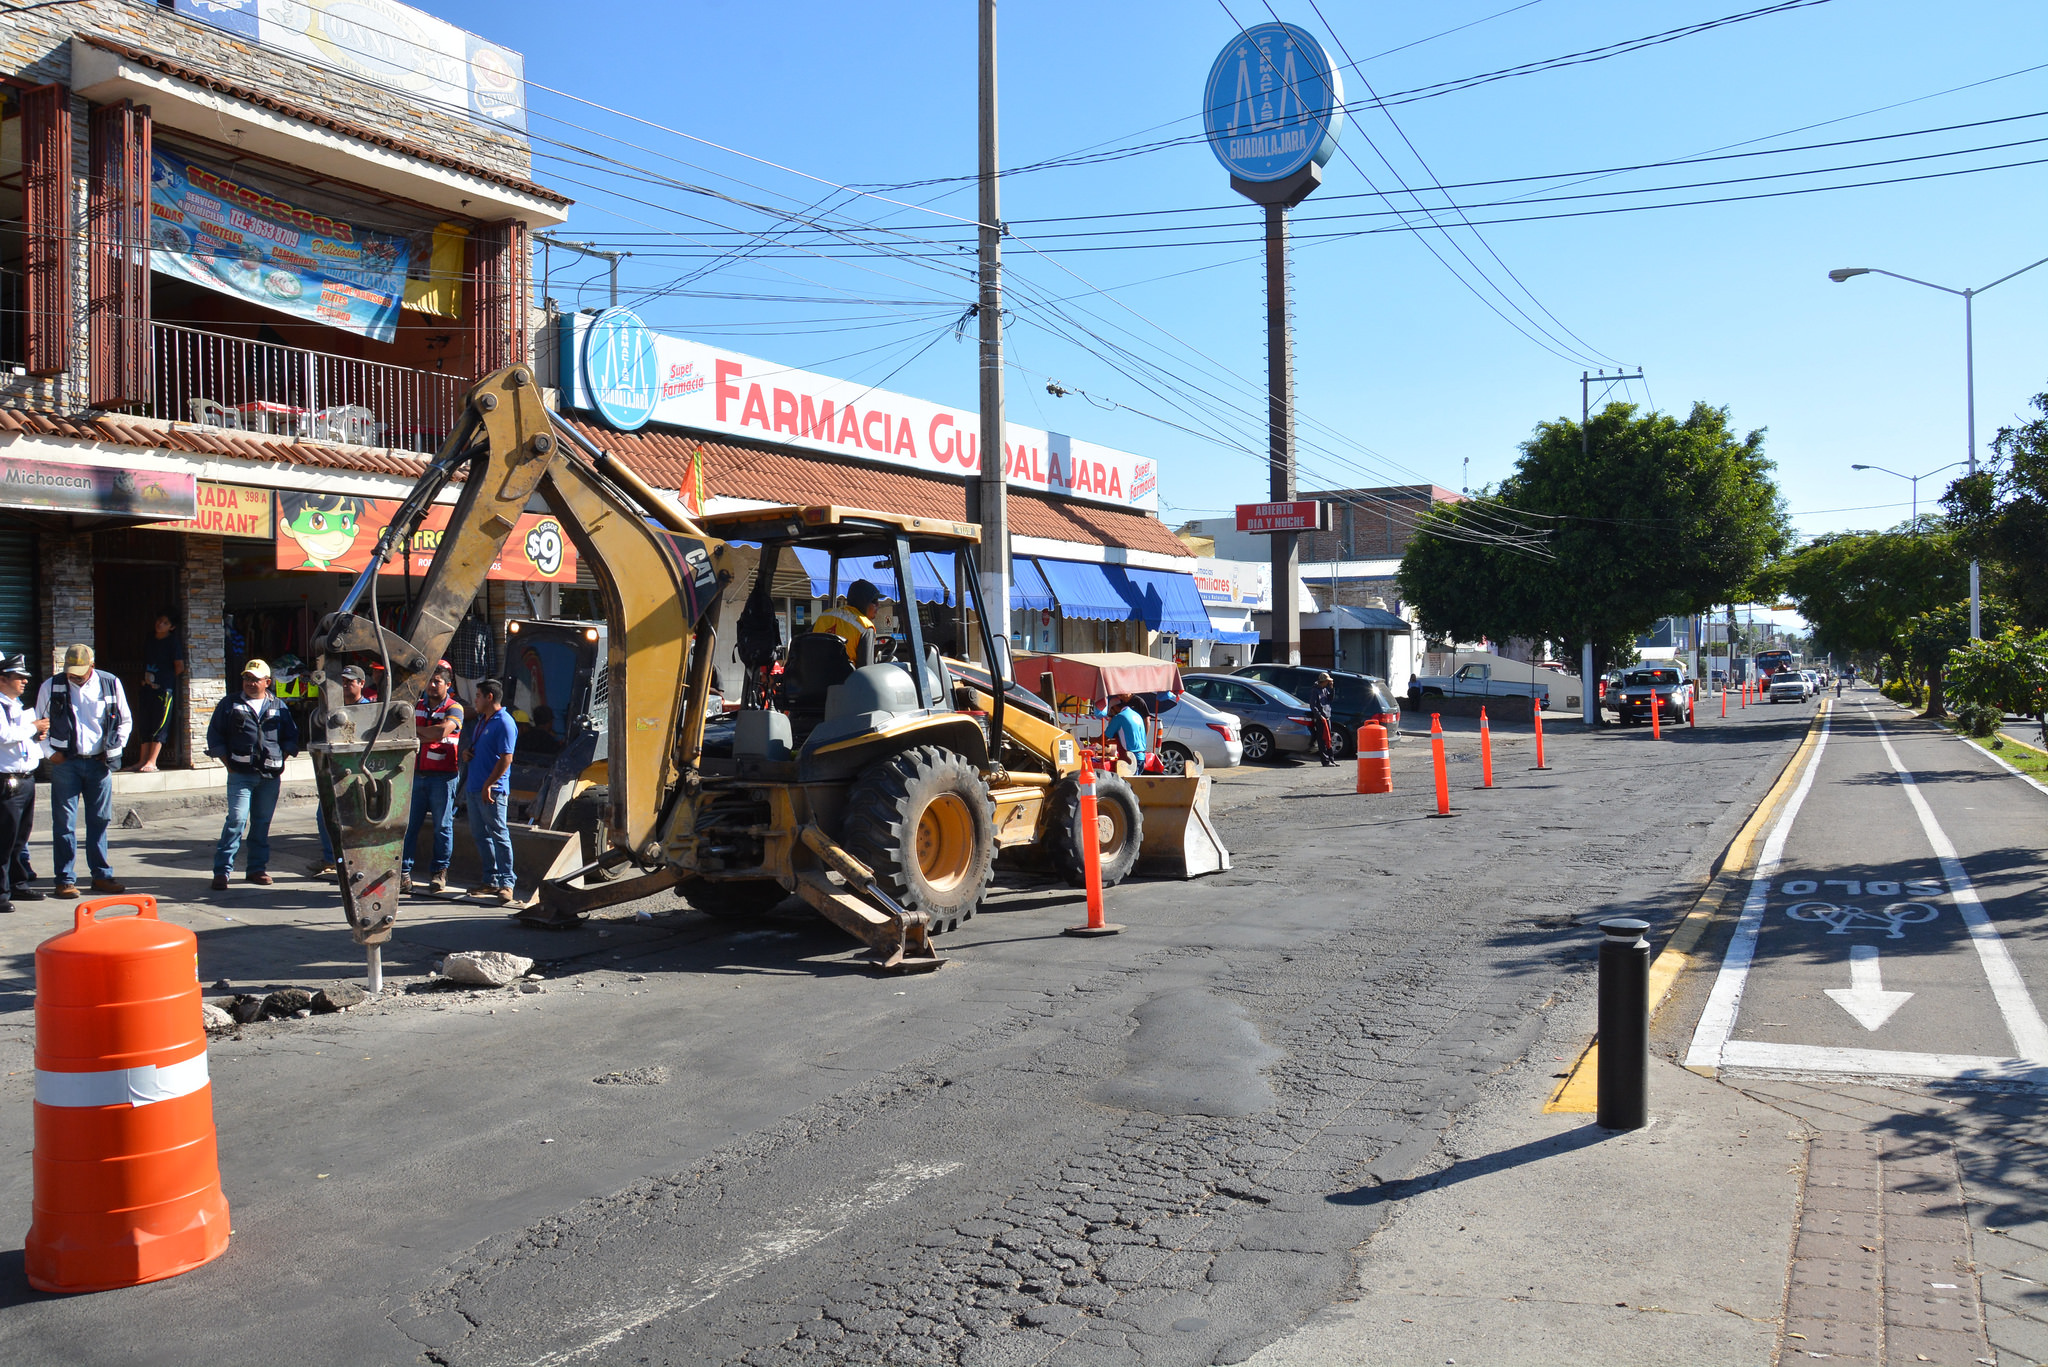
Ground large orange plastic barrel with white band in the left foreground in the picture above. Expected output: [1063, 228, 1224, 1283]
[27, 896, 227, 1291]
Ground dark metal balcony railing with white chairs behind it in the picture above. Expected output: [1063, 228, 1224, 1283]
[147, 322, 471, 451]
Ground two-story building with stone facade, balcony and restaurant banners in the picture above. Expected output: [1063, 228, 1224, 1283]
[0, 0, 575, 764]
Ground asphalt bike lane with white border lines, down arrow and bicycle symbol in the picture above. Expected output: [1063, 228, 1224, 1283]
[1688, 689, 2048, 1084]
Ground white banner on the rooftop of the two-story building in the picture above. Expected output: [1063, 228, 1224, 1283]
[174, 0, 526, 131]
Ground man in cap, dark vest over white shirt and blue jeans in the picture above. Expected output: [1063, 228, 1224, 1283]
[35, 644, 135, 898]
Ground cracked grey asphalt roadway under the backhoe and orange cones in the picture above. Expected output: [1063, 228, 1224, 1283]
[0, 707, 1810, 1367]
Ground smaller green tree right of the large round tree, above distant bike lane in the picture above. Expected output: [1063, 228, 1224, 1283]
[1761, 516, 1970, 672]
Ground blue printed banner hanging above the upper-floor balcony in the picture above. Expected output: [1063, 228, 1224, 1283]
[150, 150, 412, 342]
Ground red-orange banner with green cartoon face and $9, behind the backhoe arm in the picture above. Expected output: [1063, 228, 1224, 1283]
[276, 492, 575, 584]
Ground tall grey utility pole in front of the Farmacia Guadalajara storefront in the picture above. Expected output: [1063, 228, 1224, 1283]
[967, 0, 1010, 647]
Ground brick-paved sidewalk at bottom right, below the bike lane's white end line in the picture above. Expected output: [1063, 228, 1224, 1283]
[1726, 1078, 2048, 1367]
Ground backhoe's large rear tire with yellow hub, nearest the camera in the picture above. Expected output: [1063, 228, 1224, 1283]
[840, 746, 995, 935]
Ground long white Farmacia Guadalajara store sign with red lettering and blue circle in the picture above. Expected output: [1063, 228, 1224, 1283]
[559, 307, 1159, 510]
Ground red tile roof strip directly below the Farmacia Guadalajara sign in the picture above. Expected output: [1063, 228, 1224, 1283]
[571, 418, 1188, 555]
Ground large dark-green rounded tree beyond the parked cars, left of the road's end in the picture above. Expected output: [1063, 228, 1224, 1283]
[1397, 404, 1790, 687]
